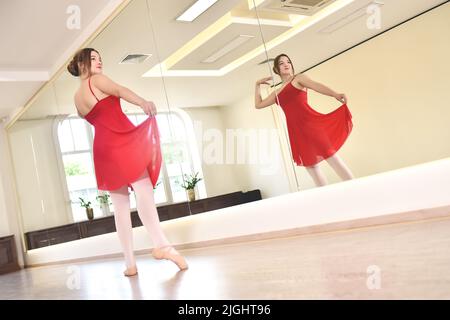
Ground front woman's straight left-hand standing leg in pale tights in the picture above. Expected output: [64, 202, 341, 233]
[110, 186, 137, 276]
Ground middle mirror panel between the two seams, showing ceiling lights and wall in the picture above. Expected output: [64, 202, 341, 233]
[144, 0, 288, 205]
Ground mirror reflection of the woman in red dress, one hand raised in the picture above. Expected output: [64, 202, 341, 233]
[255, 54, 353, 186]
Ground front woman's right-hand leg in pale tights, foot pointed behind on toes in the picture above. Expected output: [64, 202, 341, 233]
[131, 171, 187, 269]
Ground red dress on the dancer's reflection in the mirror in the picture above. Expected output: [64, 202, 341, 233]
[277, 83, 353, 167]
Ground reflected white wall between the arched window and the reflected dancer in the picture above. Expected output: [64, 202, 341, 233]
[183, 95, 289, 198]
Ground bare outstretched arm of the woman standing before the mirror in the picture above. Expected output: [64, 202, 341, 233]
[91, 74, 156, 115]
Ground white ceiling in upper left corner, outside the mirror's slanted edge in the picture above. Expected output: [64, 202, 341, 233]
[0, 0, 122, 117]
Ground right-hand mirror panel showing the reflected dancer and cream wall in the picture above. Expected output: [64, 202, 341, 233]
[255, 0, 450, 190]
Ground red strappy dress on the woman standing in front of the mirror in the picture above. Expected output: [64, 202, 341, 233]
[85, 78, 162, 191]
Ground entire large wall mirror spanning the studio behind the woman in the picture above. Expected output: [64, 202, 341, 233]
[9, 0, 450, 251]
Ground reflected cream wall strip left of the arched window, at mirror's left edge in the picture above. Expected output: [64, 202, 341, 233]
[9, 119, 71, 232]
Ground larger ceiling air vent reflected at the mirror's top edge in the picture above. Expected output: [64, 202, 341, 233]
[259, 0, 336, 16]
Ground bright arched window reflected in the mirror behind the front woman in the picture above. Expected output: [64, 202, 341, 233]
[58, 112, 206, 221]
